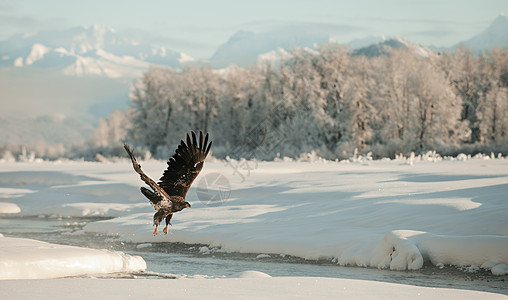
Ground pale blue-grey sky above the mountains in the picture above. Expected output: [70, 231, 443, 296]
[0, 0, 508, 59]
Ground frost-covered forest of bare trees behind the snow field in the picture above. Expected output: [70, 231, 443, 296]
[89, 44, 508, 160]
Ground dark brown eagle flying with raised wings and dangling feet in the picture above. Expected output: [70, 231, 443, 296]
[124, 131, 212, 235]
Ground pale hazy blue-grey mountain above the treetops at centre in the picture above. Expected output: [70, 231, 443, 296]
[209, 30, 330, 68]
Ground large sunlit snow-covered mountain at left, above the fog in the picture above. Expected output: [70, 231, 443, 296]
[0, 25, 193, 78]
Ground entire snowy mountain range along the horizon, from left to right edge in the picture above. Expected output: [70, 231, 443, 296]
[0, 14, 508, 78]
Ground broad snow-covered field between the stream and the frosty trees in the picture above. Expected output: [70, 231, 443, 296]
[0, 156, 508, 298]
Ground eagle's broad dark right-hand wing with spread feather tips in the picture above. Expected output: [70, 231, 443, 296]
[158, 131, 212, 199]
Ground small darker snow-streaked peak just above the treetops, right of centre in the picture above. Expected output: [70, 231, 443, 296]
[352, 37, 435, 57]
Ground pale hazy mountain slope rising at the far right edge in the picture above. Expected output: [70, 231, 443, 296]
[452, 14, 508, 53]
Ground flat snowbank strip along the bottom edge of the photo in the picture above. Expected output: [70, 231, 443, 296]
[0, 277, 506, 300]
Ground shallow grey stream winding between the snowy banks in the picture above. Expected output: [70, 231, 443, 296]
[0, 216, 508, 295]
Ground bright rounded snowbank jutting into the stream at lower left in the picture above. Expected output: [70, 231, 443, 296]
[0, 236, 146, 278]
